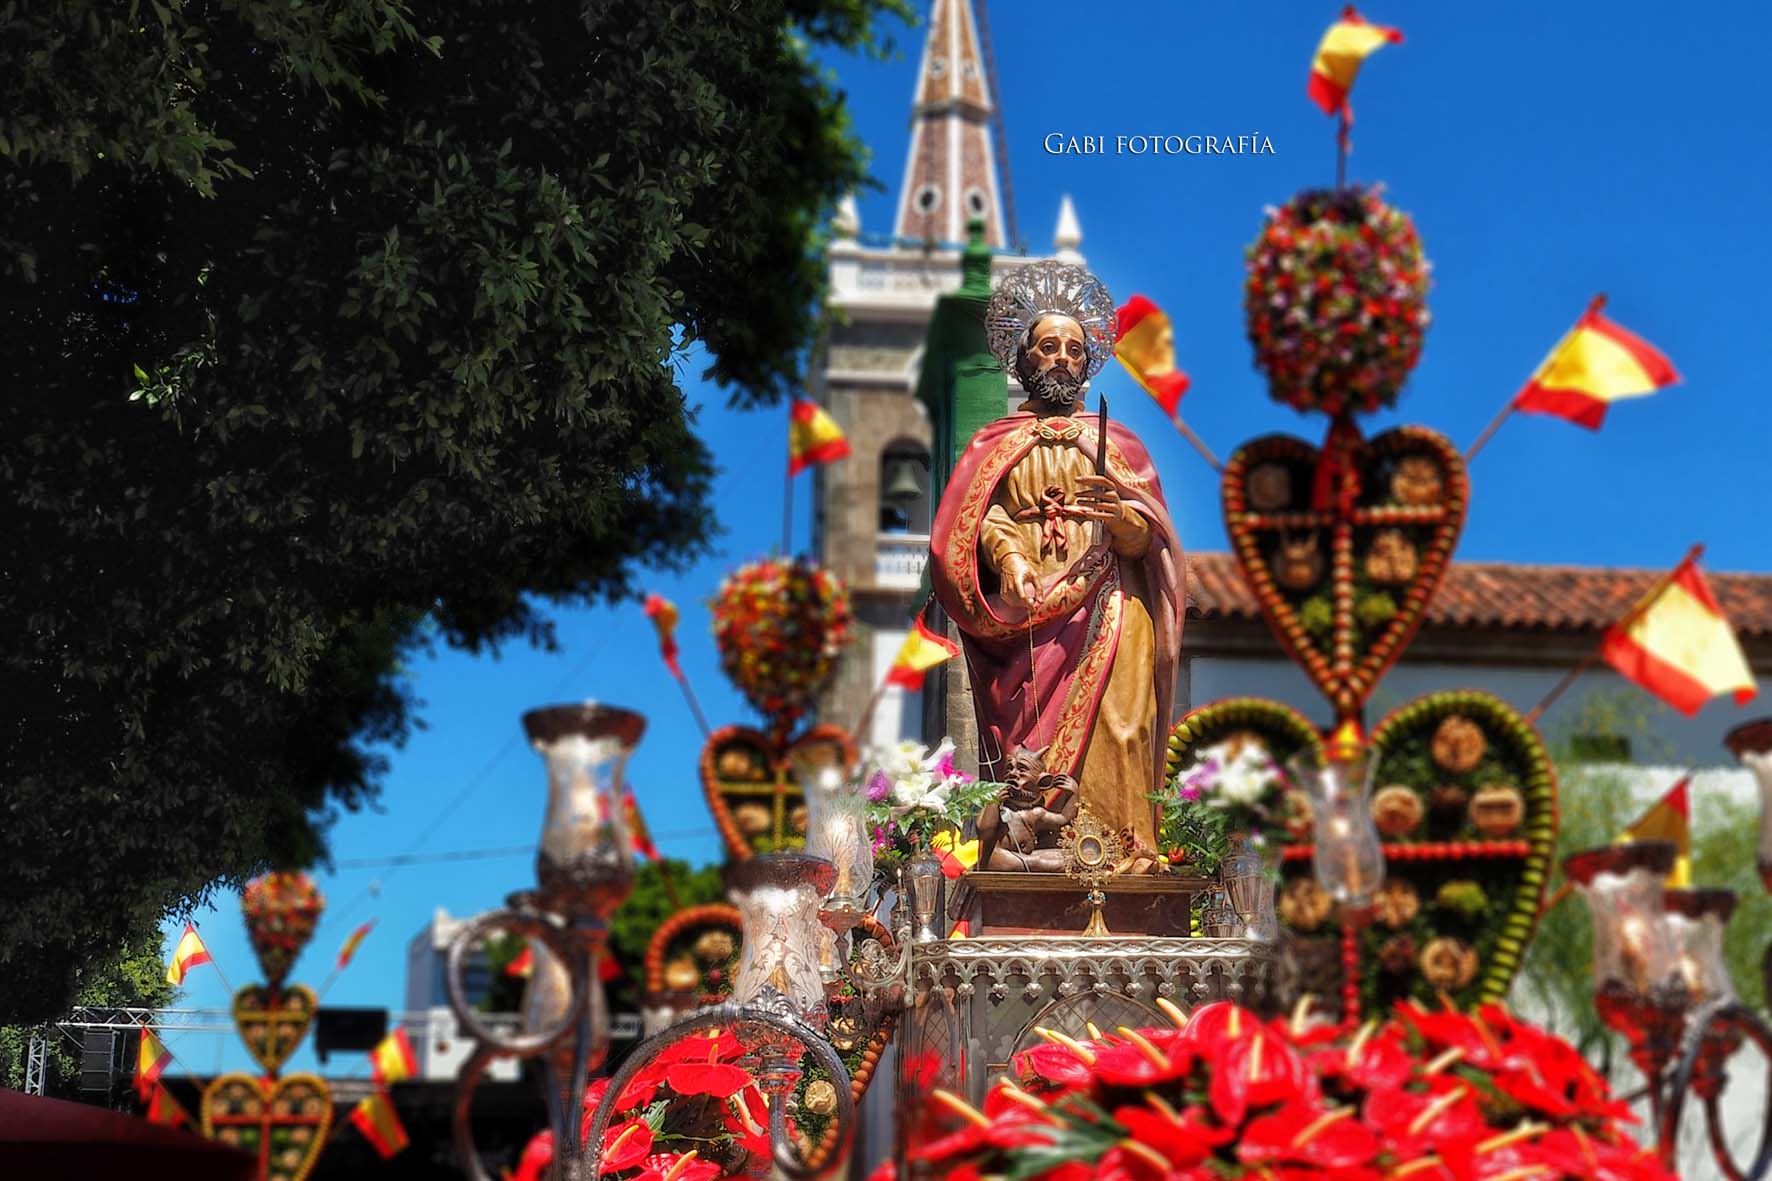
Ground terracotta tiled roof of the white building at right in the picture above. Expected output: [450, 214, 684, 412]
[1187, 553, 1772, 638]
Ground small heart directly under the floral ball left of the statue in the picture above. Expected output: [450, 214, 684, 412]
[702, 725, 858, 858]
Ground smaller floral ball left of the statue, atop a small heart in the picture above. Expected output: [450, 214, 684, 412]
[712, 559, 852, 734]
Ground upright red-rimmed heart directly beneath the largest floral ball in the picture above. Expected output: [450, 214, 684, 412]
[1221, 422, 1469, 718]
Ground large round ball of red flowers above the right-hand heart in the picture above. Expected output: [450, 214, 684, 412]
[1244, 186, 1428, 417]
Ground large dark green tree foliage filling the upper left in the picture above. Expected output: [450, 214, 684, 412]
[0, 0, 902, 1020]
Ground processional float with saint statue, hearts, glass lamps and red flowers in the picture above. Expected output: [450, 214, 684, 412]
[450, 197, 1772, 1181]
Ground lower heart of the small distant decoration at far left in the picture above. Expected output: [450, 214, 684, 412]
[200, 1075, 331, 1181]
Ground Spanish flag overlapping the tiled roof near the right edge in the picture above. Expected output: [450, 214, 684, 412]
[1600, 548, 1756, 716]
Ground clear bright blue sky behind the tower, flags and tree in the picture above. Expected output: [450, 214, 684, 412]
[155, 0, 1772, 1073]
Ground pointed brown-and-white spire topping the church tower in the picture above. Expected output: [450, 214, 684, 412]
[893, 0, 1008, 246]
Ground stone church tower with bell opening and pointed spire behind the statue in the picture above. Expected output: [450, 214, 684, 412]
[810, 0, 1083, 745]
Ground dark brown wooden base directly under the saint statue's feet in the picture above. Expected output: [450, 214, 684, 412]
[950, 871, 1214, 938]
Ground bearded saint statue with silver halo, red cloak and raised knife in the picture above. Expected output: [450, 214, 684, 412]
[930, 262, 1184, 844]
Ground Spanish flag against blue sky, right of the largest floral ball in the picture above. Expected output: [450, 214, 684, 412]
[1513, 296, 1680, 431]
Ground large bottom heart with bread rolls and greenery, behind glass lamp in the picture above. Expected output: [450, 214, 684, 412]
[1166, 690, 1556, 1016]
